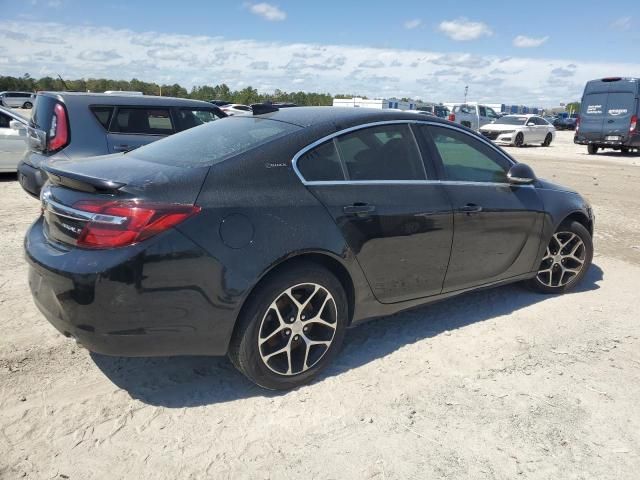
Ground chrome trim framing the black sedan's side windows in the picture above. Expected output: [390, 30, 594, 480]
[291, 120, 522, 186]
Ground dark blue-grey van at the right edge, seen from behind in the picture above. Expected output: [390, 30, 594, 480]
[573, 77, 640, 155]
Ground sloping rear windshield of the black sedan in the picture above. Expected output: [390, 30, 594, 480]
[130, 117, 301, 167]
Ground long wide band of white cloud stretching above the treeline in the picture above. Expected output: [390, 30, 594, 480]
[0, 20, 640, 106]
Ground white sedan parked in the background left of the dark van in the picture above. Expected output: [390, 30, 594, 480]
[480, 115, 556, 147]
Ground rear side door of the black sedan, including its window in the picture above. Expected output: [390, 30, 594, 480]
[296, 122, 453, 303]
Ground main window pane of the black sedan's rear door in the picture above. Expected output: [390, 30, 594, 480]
[336, 124, 426, 181]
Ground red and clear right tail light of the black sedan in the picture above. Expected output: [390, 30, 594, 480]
[73, 200, 201, 249]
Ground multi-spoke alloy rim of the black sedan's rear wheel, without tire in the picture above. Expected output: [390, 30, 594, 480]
[258, 283, 338, 376]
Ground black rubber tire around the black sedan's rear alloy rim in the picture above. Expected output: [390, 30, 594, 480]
[228, 262, 349, 390]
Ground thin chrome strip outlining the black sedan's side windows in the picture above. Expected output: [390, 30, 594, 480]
[291, 120, 517, 185]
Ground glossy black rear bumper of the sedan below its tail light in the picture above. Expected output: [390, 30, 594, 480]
[25, 219, 238, 356]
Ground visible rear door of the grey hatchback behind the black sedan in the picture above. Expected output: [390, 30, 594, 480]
[107, 106, 176, 153]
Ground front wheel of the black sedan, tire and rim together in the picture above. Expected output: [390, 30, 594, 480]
[530, 221, 593, 293]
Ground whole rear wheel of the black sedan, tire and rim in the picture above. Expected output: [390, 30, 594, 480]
[229, 263, 348, 390]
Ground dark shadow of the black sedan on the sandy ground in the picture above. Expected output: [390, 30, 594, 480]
[91, 265, 603, 408]
